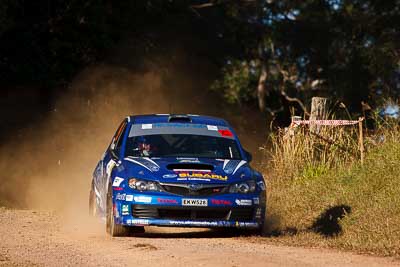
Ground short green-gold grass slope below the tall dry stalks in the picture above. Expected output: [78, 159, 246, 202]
[265, 125, 400, 256]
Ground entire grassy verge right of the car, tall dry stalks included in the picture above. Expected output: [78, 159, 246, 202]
[266, 119, 400, 256]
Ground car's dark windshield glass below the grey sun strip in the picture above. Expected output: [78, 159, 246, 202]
[125, 134, 241, 159]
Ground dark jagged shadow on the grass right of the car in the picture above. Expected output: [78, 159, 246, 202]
[310, 205, 351, 237]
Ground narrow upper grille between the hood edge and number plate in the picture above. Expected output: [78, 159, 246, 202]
[161, 184, 228, 196]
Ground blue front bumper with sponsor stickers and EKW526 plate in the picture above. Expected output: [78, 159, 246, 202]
[114, 193, 265, 229]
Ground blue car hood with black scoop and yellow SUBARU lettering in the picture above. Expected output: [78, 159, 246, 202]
[121, 157, 252, 184]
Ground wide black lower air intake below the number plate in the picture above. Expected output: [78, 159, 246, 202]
[132, 205, 254, 221]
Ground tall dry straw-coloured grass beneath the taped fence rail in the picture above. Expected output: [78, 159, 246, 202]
[271, 121, 360, 178]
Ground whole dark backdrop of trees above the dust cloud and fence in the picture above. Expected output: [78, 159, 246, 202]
[0, 0, 400, 113]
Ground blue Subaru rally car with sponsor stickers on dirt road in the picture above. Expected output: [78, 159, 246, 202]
[89, 114, 266, 236]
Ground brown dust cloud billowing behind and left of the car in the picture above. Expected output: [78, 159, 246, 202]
[0, 49, 263, 232]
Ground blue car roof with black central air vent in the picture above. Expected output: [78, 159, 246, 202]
[128, 114, 230, 127]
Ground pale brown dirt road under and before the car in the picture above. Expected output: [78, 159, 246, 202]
[0, 208, 400, 266]
